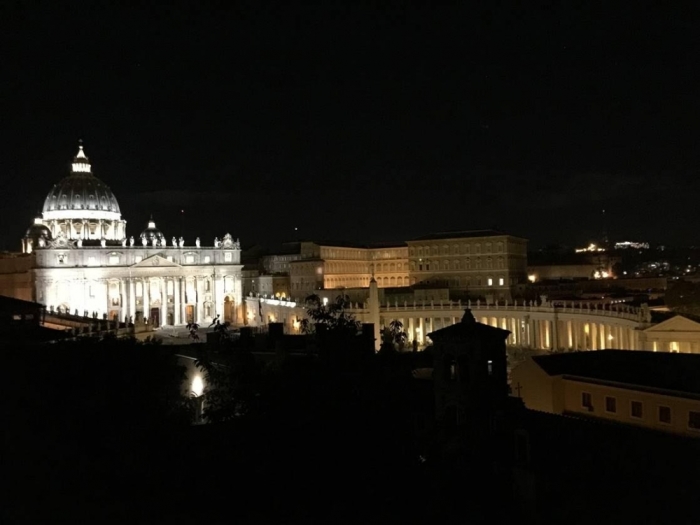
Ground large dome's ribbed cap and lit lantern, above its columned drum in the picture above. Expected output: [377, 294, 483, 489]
[43, 144, 121, 220]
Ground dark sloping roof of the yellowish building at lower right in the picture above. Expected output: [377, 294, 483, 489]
[532, 350, 700, 395]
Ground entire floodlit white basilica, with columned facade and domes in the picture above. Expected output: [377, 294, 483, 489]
[0, 141, 243, 326]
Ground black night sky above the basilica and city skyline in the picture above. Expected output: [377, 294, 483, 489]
[0, 1, 700, 249]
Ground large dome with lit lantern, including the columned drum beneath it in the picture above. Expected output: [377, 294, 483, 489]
[37, 141, 126, 241]
